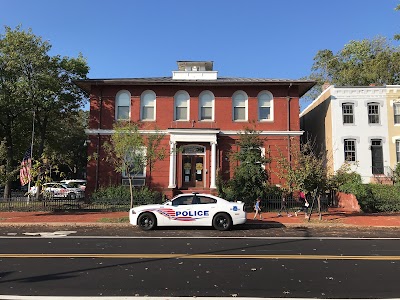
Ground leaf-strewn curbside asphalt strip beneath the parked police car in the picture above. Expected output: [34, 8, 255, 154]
[0, 223, 400, 238]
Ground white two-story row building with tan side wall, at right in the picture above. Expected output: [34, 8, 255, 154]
[300, 86, 400, 183]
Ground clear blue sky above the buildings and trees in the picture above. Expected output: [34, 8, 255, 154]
[0, 0, 400, 88]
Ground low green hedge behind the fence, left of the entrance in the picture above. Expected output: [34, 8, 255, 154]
[91, 185, 163, 206]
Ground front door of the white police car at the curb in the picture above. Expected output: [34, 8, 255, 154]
[170, 195, 195, 226]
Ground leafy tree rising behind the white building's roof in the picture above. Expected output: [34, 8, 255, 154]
[303, 37, 400, 105]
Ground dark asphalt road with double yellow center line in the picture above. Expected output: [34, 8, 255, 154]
[0, 227, 400, 298]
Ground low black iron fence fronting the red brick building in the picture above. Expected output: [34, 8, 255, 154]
[0, 194, 332, 213]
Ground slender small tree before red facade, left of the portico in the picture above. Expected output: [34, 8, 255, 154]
[103, 122, 165, 207]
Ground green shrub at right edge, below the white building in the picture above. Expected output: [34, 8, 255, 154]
[354, 184, 400, 212]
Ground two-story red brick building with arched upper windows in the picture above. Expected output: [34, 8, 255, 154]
[76, 61, 314, 196]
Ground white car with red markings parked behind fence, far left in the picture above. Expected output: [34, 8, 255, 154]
[29, 182, 85, 200]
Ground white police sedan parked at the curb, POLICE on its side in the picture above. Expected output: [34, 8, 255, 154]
[129, 193, 246, 230]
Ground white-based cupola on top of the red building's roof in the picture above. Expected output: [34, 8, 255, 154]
[172, 61, 218, 80]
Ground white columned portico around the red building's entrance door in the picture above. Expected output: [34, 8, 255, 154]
[167, 129, 220, 189]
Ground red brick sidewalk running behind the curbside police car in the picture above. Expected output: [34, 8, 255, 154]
[0, 208, 400, 227]
